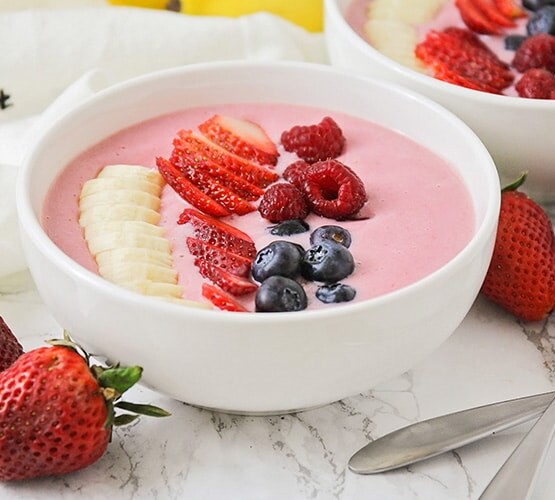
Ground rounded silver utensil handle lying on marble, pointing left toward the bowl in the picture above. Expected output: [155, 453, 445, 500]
[349, 392, 555, 474]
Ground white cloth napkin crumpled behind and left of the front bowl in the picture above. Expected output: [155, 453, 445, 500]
[0, 4, 327, 281]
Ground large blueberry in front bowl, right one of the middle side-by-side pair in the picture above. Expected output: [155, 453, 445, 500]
[301, 241, 355, 283]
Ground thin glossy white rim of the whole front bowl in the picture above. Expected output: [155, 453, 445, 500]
[16, 61, 501, 324]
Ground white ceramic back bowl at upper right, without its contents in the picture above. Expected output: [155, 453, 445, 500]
[324, 0, 555, 202]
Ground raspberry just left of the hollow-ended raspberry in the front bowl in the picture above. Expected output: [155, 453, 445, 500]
[258, 183, 308, 222]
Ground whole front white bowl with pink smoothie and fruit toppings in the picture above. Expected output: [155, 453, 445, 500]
[17, 63, 500, 413]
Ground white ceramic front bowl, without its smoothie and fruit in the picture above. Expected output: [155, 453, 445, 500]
[17, 63, 499, 413]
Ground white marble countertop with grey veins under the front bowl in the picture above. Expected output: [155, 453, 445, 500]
[0, 207, 555, 500]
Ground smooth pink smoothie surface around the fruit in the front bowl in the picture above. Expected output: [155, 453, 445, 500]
[42, 104, 474, 310]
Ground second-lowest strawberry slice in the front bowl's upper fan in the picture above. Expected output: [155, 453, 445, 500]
[174, 162, 256, 215]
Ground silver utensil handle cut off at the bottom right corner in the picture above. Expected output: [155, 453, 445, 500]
[480, 400, 555, 500]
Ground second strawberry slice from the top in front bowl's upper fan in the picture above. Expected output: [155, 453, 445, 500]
[174, 130, 279, 188]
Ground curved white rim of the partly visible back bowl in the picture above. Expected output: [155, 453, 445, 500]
[324, 0, 555, 110]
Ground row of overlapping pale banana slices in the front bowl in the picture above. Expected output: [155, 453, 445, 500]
[79, 165, 209, 307]
